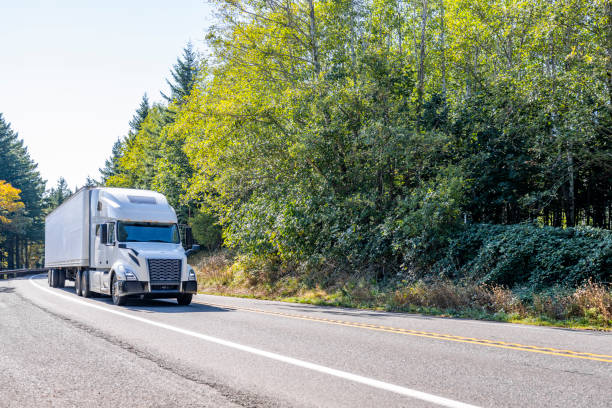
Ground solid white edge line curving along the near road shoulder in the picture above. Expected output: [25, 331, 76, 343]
[29, 275, 479, 408]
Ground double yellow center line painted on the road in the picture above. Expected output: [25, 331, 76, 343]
[197, 301, 612, 363]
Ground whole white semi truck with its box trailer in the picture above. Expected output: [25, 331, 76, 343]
[45, 187, 197, 305]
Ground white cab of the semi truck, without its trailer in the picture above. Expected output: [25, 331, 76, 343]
[88, 188, 197, 304]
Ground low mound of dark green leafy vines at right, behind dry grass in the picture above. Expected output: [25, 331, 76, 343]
[435, 223, 612, 290]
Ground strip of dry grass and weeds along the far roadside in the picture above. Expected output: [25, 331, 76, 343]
[190, 249, 612, 328]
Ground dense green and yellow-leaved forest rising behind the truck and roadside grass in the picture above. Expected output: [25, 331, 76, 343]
[0, 0, 612, 326]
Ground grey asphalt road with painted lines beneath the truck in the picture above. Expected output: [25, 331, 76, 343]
[0, 277, 612, 408]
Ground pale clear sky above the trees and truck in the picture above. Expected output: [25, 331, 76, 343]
[0, 0, 213, 189]
